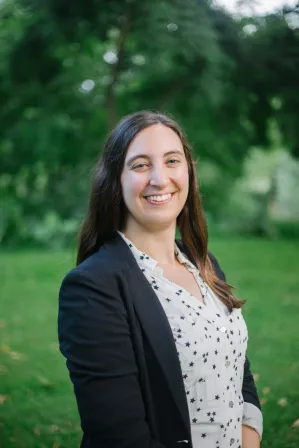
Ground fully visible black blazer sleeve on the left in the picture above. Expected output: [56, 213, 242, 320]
[58, 268, 163, 448]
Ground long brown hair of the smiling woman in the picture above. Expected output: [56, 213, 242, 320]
[77, 111, 244, 310]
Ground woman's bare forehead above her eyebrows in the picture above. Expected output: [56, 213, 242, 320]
[126, 124, 183, 159]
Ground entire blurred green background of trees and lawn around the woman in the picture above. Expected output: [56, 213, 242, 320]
[0, 0, 299, 448]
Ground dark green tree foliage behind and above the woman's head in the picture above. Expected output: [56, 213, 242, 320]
[0, 0, 299, 244]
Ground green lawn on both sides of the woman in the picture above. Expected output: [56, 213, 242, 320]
[0, 239, 299, 448]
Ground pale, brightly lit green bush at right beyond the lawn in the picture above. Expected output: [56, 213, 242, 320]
[213, 145, 299, 239]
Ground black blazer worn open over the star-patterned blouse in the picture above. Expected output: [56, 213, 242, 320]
[58, 234, 260, 448]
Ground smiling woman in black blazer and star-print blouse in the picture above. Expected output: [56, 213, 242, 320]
[59, 111, 262, 448]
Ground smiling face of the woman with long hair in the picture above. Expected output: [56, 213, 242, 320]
[121, 124, 189, 231]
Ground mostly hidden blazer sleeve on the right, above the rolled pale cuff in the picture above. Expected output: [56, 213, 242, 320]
[209, 252, 261, 410]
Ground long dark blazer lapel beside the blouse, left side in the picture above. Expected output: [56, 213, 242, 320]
[105, 234, 190, 433]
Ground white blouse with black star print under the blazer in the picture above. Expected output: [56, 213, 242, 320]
[119, 232, 262, 448]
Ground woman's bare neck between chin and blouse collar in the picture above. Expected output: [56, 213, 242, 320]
[122, 222, 176, 265]
